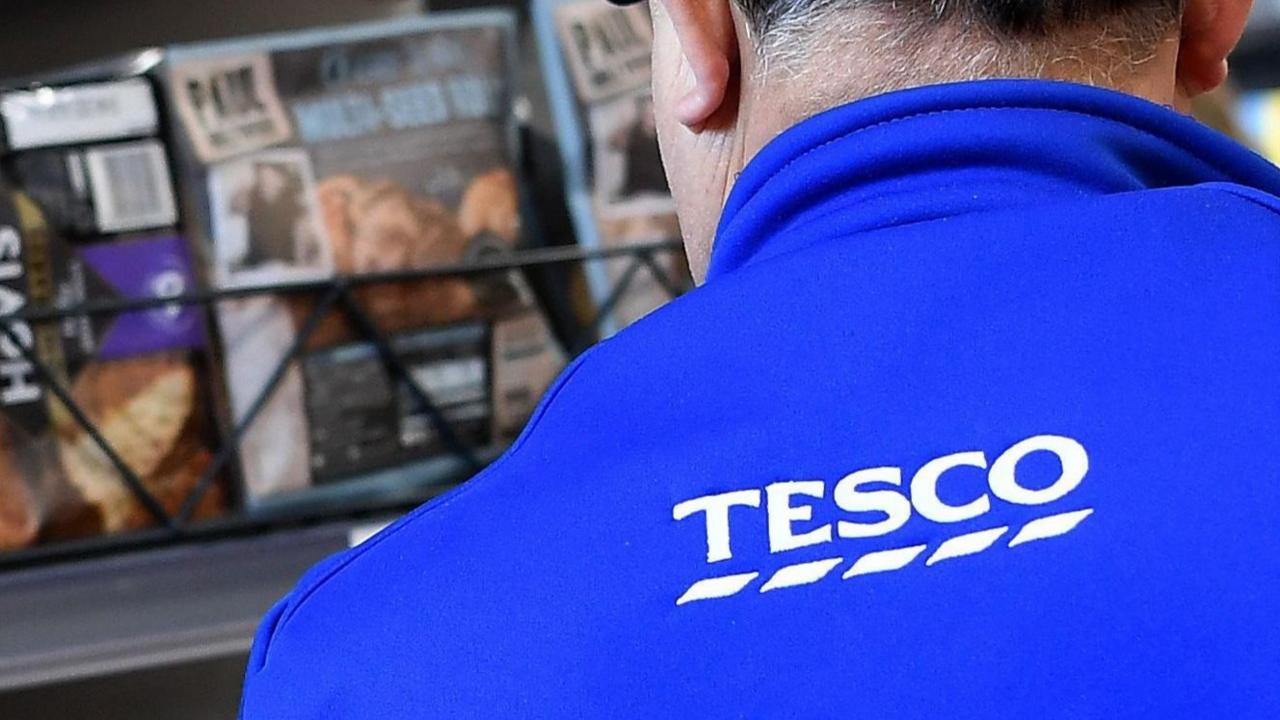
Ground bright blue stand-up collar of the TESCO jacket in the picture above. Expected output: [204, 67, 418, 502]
[708, 79, 1280, 282]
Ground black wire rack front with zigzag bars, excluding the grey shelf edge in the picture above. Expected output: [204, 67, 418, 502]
[0, 241, 684, 571]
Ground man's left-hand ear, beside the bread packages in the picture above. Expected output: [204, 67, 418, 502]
[655, 0, 739, 127]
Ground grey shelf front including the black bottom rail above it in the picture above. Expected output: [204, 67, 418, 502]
[0, 445, 504, 694]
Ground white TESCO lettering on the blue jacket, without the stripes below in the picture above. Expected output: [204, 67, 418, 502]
[672, 436, 1089, 562]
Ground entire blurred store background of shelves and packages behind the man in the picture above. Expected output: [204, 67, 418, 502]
[0, 0, 1280, 720]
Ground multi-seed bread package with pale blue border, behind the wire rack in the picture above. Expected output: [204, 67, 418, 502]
[164, 10, 564, 507]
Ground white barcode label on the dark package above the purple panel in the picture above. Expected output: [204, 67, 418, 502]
[86, 141, 178, 232]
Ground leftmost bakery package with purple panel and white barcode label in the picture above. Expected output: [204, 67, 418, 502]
[0, 51, 227, 546]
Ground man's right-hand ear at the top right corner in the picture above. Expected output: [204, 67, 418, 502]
[1178, 0, 1253, 97]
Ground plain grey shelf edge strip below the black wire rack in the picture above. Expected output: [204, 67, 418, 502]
[0, 509, 385, 692]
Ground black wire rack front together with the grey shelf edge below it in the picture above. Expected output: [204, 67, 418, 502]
[0, 241, 687, 692]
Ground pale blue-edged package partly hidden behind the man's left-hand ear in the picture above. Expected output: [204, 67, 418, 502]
[532, 0, 685, 332]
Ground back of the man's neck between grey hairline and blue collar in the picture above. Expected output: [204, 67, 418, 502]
[681, 16, 1185, 278]
